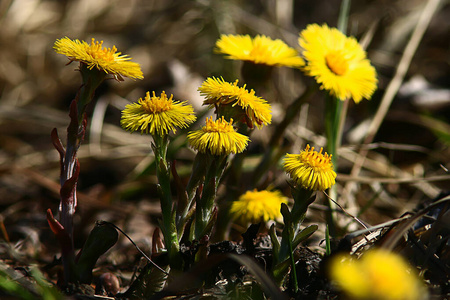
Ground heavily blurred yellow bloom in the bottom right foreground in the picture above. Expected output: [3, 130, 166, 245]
[330, 249, 426, 300]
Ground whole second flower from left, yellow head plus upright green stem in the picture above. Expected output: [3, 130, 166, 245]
[120, 91, 196, 269]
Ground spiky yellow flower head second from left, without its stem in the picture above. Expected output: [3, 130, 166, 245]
[120, 92, 196, 136]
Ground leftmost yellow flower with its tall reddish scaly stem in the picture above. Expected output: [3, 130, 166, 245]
[47, 37, 143, 284]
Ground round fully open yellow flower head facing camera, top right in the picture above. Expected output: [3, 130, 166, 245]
[299, 24, 377, 103]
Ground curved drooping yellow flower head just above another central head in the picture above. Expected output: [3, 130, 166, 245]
[198, 77, 272, 128]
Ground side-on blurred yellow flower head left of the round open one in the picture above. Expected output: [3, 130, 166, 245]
[215, 34, 304, 68]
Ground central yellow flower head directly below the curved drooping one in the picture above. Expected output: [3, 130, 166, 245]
[187, 117, 250, 155]
